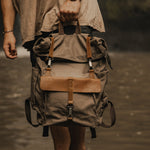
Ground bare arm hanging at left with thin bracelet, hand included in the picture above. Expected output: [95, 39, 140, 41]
[1, 0, 17, 59]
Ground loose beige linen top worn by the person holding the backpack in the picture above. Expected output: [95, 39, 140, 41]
[13, 0, 105, 45]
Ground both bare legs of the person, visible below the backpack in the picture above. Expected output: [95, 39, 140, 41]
[50, 126, 86, 150]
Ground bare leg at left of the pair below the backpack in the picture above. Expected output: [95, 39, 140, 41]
[50, 126, 71, 150]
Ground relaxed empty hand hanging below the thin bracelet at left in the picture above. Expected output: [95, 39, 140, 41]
[3, 32, 17, 59]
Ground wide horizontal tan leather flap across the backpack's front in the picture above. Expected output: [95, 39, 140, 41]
[40, 76, 101, 93]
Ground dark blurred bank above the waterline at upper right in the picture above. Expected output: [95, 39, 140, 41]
[99, 0, 150, 51]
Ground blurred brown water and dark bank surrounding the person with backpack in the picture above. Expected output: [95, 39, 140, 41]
[0, 0, 150, 150]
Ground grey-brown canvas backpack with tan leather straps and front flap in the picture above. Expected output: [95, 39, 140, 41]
[25, 22, 116, 138]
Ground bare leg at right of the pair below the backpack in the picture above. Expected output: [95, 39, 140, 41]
[69, 126, 86, 150]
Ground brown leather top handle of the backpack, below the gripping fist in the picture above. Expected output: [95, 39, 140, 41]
[58, 19, 81, 35]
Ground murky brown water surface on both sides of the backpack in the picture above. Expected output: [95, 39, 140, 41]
[0, 52, 150, 150]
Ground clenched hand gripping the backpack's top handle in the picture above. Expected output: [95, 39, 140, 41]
[59, 0, 81, 22]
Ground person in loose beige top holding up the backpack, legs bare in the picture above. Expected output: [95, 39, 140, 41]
[1, 0, 105, 150]
